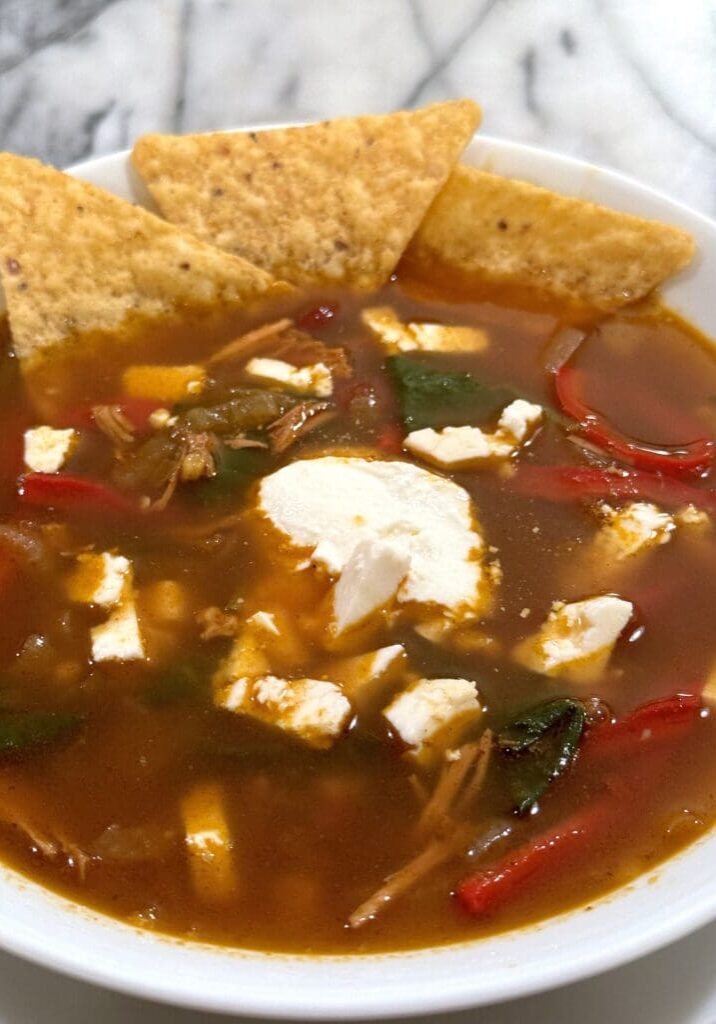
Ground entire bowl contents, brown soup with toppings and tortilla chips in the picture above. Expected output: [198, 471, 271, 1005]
[0, 100, 716, 953]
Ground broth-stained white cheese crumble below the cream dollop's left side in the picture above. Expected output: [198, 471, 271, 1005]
[216, 676, 351, 749]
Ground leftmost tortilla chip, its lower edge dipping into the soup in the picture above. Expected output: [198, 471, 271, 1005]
[0, 154, 289, 360]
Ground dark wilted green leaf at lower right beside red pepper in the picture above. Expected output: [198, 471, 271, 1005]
[498, 697, 586, 814]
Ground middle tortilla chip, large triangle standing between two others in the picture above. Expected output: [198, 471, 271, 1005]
[132, 99, 479, 289]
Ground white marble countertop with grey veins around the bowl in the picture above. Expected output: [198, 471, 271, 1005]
[0, 0, 716, 1024]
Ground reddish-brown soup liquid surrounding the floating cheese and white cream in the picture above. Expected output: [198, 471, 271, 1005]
[0, 274, 716, 952]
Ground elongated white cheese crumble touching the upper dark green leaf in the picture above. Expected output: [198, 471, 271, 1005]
[405, 398, 543, 469]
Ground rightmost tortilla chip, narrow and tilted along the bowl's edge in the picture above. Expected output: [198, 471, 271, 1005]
[406, 166, 694, 309]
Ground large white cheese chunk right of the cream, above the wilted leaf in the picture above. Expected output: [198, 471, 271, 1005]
[514, 594, 634, 683]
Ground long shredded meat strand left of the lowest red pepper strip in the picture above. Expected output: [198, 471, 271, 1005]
[348, 729, 493, 928]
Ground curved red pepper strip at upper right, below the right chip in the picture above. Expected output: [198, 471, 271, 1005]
[554, 366, 715, 477]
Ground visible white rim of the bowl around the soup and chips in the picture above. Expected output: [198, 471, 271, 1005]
[0, 130, 716, 1020]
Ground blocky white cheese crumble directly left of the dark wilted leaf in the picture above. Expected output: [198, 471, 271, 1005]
[383, 679, 481, 757]
